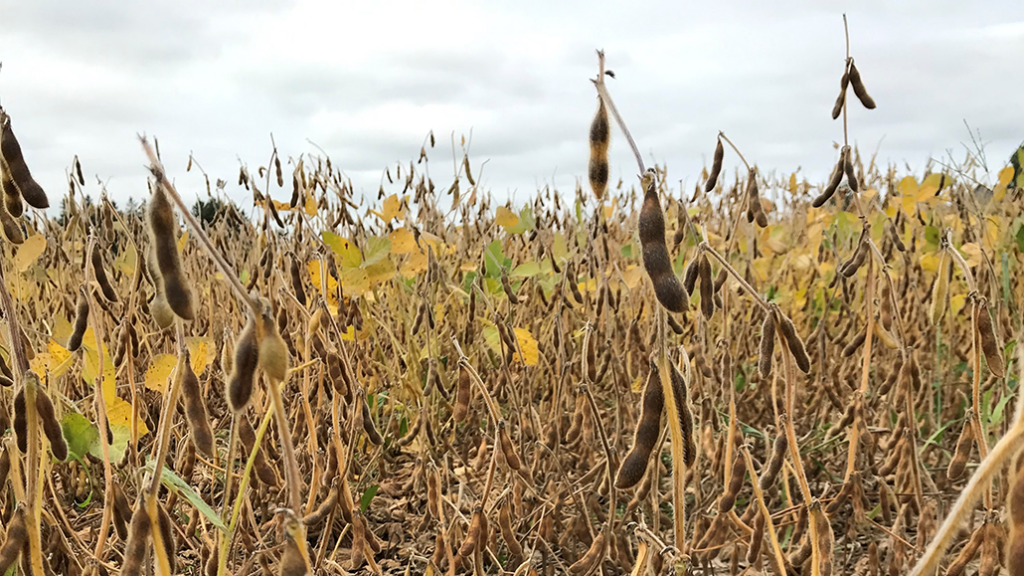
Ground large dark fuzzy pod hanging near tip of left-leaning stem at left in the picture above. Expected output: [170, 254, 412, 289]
[146, 186, 196, 321]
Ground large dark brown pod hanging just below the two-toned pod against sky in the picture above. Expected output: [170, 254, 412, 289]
[639, 170, 689, 314]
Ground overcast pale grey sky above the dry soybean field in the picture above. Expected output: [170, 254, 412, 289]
[0, 0, 1024, 211]
